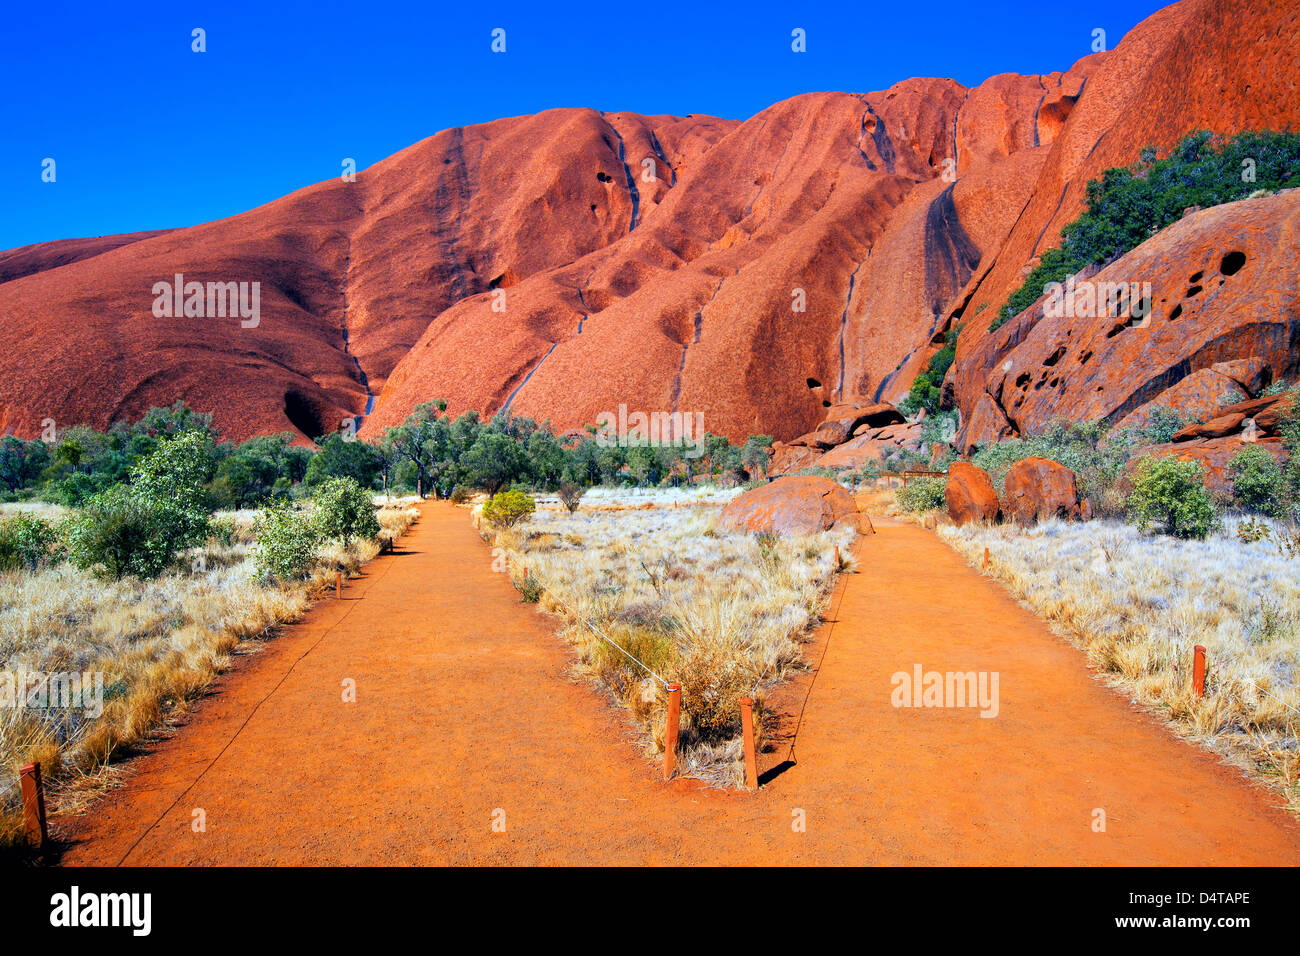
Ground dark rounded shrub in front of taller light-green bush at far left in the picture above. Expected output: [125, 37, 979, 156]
[68, 485, 181, 578]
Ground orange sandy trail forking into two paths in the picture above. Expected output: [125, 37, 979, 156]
[56, 502, 1300, 865]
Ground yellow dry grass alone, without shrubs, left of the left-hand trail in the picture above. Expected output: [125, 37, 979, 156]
[0, 501, 419, 852]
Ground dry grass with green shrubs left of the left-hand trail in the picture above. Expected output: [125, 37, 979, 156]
[0, 496, 417, 856]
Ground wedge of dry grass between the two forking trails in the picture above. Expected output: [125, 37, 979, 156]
[484, 489, 855, 786]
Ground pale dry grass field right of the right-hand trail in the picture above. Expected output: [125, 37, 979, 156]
[940, 519, 1300, 812]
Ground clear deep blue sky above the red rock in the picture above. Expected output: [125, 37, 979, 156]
[0, 0, 1164, 248]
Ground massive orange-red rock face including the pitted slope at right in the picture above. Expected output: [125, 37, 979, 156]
[0, 0, 1300, 444]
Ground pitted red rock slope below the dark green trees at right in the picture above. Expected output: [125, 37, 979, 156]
[958, 190, 1300, 447]
